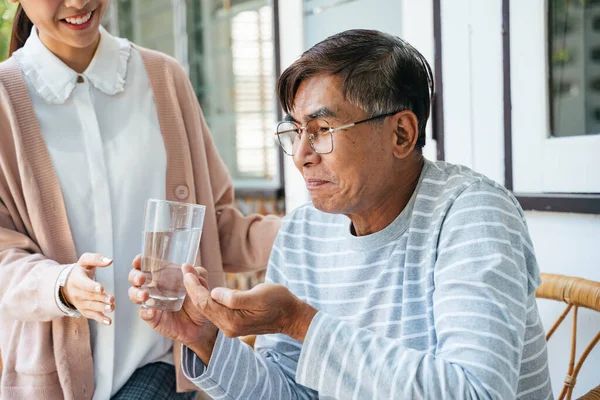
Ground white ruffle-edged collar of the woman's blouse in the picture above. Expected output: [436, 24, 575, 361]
[13, 27, 131, 104]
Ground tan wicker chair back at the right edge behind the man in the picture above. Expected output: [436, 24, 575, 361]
[536, 274, 600, 400]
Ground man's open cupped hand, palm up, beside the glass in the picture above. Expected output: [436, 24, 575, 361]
[184, 274, 317, 342]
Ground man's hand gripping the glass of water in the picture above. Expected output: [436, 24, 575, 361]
[129, 255, 218, 365]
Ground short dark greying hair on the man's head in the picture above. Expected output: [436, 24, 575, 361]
[277, 29, 433, 148]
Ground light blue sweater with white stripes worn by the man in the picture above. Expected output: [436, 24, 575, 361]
[182, 161, 552, 400]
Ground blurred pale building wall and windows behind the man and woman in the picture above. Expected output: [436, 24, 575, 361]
[0, 0, 600, 397]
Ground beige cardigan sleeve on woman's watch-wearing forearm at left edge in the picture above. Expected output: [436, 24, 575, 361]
[0, 199, 65, 321]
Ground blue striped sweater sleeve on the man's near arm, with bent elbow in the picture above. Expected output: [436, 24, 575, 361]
[296, 185, 545, 399]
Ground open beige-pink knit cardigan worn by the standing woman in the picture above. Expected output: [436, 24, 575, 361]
[0, 47, 279, 400]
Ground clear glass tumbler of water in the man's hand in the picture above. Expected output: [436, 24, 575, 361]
[142, 199, 206, 311]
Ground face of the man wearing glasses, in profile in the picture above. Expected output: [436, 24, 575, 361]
[290, 75, 395, 215]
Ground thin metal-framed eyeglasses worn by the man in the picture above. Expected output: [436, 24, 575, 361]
[275, 111, 397, 156]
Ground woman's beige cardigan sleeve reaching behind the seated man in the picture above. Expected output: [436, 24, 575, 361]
[172, 57, 280, 272]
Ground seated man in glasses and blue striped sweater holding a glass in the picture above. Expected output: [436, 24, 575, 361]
[130, 30, 552, 400]
